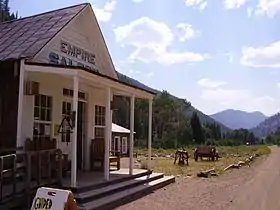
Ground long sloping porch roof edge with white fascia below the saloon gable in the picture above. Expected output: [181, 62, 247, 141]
[24, 61, 157, 99]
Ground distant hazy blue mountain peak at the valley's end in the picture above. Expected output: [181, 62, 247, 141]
[210, 109, 267, 129]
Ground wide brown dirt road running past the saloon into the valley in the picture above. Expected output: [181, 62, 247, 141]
[118, 147, 280, 210]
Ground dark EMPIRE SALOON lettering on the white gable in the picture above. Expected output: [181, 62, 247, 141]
[49, 40, 96, 71]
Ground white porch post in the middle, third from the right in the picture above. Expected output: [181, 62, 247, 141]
[104, 87, 112, 181]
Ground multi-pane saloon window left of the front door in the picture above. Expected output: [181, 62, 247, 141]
[33, 95, 52, 140]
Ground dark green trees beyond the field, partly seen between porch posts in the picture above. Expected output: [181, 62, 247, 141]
[113, 91, 258, 148]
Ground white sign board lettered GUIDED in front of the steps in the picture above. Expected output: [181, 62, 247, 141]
[31, 187, 70, 210]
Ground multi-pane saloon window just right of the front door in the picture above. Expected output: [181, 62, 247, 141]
[94, 105, 106, 139]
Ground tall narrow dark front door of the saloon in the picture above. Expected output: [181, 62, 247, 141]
[77, 101, 86, 170]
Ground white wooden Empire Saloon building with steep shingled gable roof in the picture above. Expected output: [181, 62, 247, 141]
[0, 3, 155, 186]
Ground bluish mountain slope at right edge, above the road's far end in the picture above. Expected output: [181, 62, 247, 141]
[251, 113, 280, 138]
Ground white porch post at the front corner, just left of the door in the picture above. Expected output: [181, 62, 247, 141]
[71, 75, 79, 187]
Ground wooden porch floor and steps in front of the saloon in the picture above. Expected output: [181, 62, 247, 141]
[61, 169, 175, 210]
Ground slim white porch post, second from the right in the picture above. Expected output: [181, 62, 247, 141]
[129, 95, 135, 175]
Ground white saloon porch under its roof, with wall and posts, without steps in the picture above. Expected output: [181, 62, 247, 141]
[17, 61, 154, 188]
